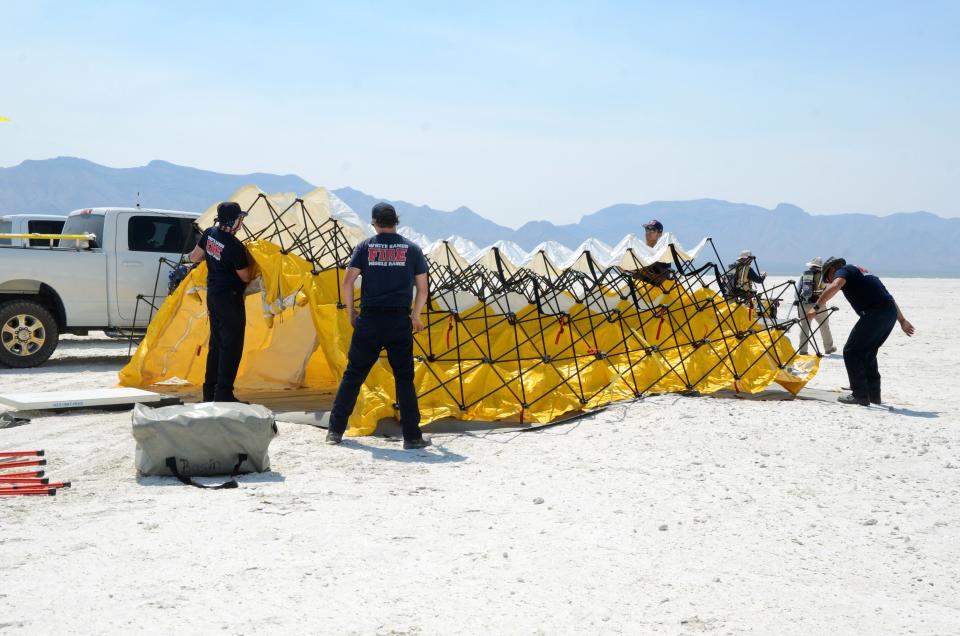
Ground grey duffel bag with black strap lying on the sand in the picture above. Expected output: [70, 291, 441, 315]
[133, 402, 278, 488]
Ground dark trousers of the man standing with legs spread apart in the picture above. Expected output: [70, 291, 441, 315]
[330, 307, 423, 441]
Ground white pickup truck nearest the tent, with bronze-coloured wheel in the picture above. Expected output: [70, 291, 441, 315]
[0, 208, 199, 368]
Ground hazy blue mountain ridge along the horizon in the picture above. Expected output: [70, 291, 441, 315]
[0, 157, 960, 276]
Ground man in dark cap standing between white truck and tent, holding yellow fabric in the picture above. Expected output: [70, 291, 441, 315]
[190, 201, 251, 402]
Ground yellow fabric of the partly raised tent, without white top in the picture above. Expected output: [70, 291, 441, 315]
[120, 234, 819, 435]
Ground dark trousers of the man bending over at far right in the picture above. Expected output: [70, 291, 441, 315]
[843, 305, 897, 402]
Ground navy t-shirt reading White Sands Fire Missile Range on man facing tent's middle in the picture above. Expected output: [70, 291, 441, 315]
[349, 232, 427, 308]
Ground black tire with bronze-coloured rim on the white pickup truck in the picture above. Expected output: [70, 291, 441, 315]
[0, 300, 60, 369]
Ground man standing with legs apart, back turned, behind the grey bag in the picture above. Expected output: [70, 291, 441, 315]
[327, 203, 430, 449]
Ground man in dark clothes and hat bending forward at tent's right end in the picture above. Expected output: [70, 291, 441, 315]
[807, 256, 914, 406]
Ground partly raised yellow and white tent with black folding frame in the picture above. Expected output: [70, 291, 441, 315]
[120, 186, 818, 435]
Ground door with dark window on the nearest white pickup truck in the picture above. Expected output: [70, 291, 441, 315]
[115, 211, 196, 327]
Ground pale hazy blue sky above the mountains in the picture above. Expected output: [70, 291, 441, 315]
[0, 0, 960, 226]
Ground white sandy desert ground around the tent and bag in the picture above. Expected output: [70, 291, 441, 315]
[0, 280, 960, 634]
